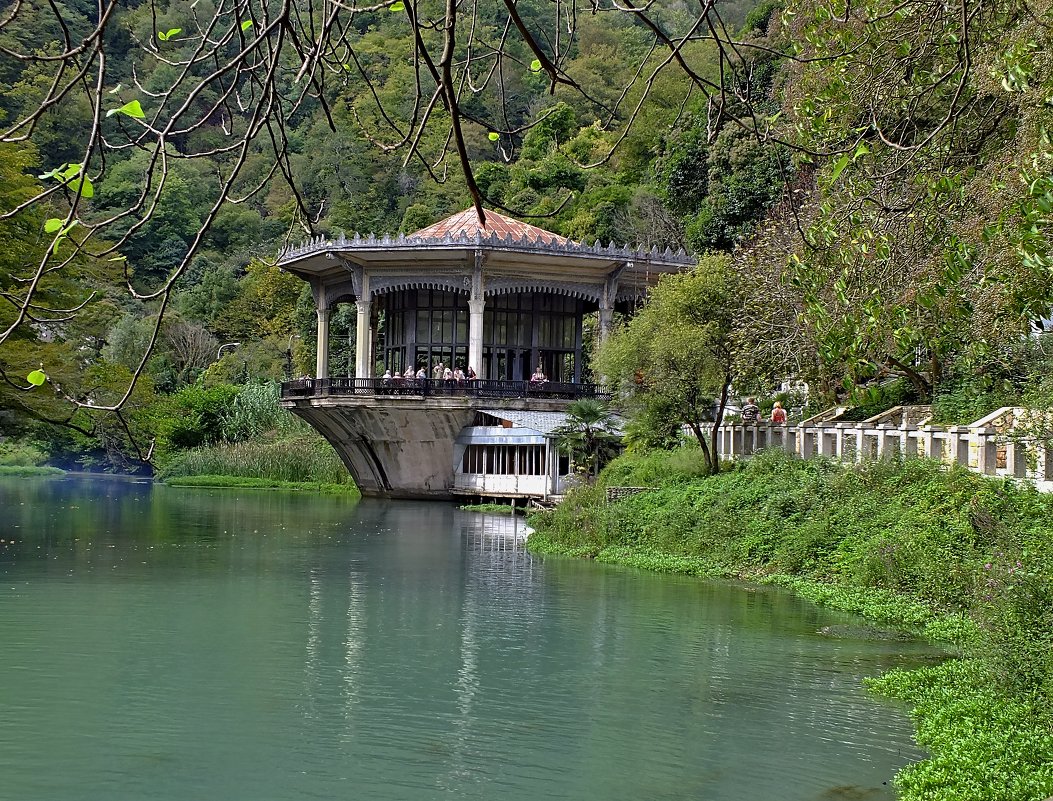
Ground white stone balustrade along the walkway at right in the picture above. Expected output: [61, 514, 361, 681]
[717, 406, 1053, 492]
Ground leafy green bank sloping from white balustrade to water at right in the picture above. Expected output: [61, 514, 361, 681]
[529, 450, 1053, 801]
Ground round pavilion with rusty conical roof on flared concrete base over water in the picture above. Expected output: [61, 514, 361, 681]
[278, 208, 694, 498]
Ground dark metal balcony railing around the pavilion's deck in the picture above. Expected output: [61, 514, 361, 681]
[281, 378, 613, 400]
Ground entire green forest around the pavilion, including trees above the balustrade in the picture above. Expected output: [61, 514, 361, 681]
[0, 0, 1053, 469]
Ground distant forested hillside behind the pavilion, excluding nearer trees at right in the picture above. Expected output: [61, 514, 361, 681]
[0, 1, 781, 467]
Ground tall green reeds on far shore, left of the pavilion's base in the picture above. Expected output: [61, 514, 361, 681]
[157, 432, 354, 487]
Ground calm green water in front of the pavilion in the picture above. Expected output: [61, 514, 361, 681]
[0, 477, 935, 801]
